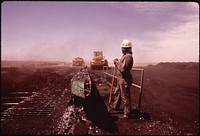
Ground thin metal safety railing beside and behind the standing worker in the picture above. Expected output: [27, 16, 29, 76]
[103, 66, 144, 111]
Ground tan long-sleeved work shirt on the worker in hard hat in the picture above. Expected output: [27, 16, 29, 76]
[116, 53, 133, 83]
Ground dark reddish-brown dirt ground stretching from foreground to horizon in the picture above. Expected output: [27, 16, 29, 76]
[1, 63, 199, 135]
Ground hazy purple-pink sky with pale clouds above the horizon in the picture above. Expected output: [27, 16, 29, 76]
[1, 1, 199, 63]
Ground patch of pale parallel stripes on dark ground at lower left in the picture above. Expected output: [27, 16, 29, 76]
[1, 93, 56, 121]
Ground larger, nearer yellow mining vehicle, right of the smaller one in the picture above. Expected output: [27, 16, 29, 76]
[90, 51, 108, 70]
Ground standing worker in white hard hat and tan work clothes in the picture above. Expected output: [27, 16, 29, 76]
[108, 40, 133, 118]
